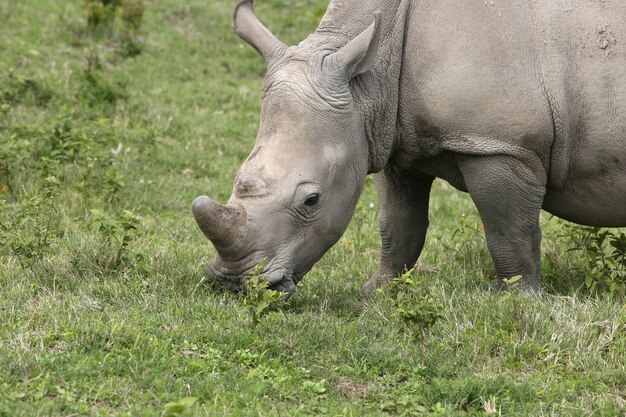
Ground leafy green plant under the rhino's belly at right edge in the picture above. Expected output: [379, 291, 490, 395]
[569, 226, 626, 296]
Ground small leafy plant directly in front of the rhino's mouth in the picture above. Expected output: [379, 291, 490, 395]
[243, 260, 284, 327]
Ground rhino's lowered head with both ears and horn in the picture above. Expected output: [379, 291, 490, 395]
[192, 0, 379, 295]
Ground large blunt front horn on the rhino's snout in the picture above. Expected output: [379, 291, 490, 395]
[191, 196, 246, 255]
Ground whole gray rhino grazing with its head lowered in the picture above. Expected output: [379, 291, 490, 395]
[193, 0, 626, 294]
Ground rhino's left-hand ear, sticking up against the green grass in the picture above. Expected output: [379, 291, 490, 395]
[233, 0, 287, 63]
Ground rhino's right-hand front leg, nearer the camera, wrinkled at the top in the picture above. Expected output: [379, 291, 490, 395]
[457, 155, 546, 291]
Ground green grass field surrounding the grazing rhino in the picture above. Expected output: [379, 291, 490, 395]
[0, 0, 626, 416]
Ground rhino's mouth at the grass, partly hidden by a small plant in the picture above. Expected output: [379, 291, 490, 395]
[207, 261, 303, 298]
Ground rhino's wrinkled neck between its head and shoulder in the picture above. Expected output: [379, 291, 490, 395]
[313, 0, 411, 173]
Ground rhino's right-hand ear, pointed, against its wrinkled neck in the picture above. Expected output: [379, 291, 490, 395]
[327, 11, 380, 80]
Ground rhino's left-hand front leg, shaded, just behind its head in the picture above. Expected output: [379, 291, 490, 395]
[361, 166, 434, 294]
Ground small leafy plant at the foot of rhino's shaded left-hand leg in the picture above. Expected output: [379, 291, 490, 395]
[382, 269, 443, 342]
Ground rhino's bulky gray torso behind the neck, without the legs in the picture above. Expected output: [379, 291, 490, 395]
[399, 0, 626, 225]
